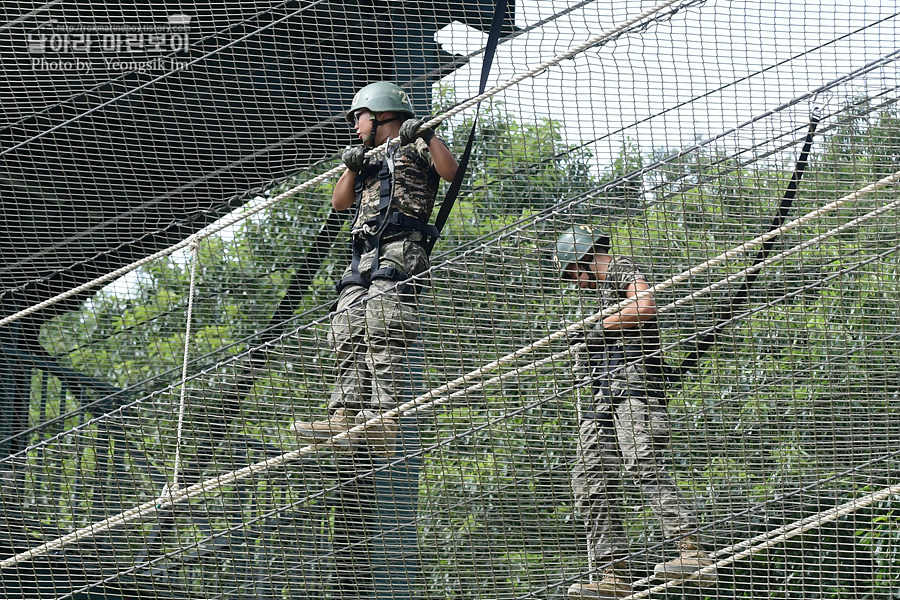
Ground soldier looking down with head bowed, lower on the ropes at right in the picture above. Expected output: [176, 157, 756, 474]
[556, 225, 716, 598]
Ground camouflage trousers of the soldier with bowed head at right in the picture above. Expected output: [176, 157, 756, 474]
[572, 367, 697, 563]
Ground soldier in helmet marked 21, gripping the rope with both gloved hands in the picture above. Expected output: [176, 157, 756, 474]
[291, 82, 457, 456]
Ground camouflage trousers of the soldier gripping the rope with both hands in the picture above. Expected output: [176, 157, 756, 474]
[328, 238, 428, 412]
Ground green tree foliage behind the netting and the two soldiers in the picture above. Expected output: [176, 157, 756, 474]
[22, 99, 900, 599]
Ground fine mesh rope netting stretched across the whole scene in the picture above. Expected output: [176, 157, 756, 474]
[0, 0, 900, 600]
